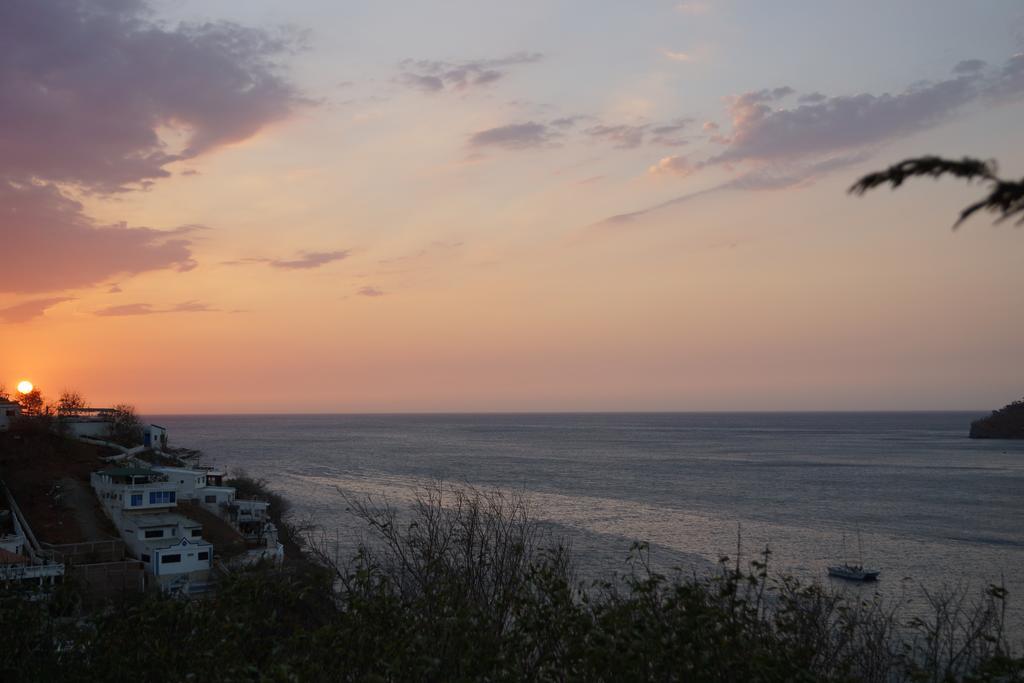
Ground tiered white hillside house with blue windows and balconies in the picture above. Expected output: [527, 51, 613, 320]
[91, 467, 213, 590]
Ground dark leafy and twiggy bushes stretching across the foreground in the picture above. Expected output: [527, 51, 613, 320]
[0, 487, 1024, 681]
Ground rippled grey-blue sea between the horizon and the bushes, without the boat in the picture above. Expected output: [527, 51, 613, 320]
[153, 413, 1024, 627]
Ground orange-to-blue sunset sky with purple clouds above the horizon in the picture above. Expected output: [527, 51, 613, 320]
[0, 0, 1024, 414]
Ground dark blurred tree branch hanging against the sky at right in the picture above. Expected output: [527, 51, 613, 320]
[849, 157, 1024, 229]
